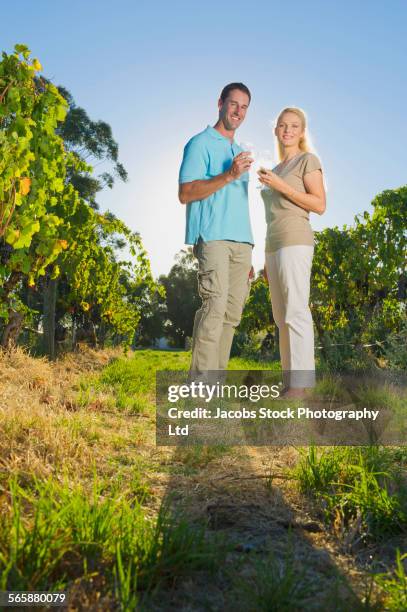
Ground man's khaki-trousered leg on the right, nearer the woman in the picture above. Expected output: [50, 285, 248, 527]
[218, 242, 252, 370]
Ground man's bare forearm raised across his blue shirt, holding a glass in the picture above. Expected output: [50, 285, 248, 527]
[178, 151, 253, 204]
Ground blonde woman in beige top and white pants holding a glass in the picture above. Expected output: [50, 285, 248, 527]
[258, 108, 326, 397]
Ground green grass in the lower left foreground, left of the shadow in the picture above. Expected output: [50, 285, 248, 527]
[0, 478, 230, 609]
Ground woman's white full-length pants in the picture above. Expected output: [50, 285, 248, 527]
[266, 245, 315, 387]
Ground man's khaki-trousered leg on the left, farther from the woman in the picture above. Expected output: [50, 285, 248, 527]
[191, 240, 229, 375]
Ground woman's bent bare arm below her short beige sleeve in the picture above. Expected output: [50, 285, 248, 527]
[258, 170, 326, 215]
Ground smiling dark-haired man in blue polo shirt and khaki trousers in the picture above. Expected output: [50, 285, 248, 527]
[179, 83, 253, 374]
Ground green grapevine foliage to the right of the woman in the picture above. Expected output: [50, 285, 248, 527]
[311, 187, 407, 365]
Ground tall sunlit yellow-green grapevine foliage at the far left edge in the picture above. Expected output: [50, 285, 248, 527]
[0, 45, 86, 319]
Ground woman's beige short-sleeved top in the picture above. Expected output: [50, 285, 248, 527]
[261, 153, 321, 253]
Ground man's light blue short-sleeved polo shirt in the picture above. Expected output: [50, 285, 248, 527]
[179, 125, 254, 244]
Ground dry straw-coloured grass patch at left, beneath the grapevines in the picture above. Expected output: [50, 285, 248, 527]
[0, 347, 148, 478]
